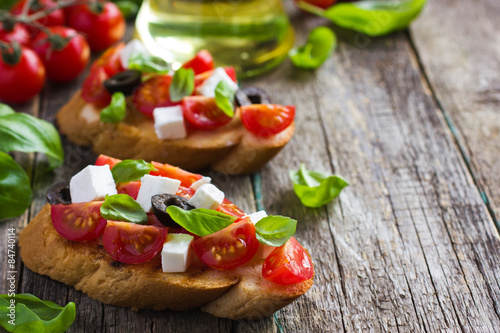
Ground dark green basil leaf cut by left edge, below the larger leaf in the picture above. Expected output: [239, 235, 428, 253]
[0, 152, 33, 219]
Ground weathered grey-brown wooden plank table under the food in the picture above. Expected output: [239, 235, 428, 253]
[0, 0, 500, 332]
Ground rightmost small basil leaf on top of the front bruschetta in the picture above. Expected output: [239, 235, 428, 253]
[255, 216, 297, 246]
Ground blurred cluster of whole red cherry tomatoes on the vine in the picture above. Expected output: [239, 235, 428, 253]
[0, 0, 125, 103]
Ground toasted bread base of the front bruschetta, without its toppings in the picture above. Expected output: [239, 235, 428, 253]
[19, 204, 313, 319]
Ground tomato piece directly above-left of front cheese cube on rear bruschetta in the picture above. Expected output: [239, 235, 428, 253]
[133, 75, 179, 118]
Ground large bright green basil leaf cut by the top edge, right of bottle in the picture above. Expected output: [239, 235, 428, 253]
[323, 0, 427, 37]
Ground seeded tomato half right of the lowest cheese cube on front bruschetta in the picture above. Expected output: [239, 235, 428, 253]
[192, 218, 259, 270]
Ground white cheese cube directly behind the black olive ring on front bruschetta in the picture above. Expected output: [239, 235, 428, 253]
[136, 175, 181, 213]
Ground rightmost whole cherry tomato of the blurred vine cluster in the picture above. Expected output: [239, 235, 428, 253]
[68, 2, 125, 51]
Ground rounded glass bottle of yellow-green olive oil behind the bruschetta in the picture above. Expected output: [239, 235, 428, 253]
[136, 0, 294, 77]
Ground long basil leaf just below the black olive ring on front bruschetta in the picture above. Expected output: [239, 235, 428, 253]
[167, 206, 236, 236]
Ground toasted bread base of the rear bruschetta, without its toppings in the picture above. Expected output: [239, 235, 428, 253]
[57, 92, 295, 174]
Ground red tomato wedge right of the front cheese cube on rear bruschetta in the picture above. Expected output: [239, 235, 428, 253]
[181, 96, 231, 130]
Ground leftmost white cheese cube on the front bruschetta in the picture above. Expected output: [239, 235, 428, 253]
[69, 165, 118, 203]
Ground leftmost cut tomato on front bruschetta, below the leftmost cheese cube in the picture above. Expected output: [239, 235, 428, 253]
[50, 201, 106, 241]
